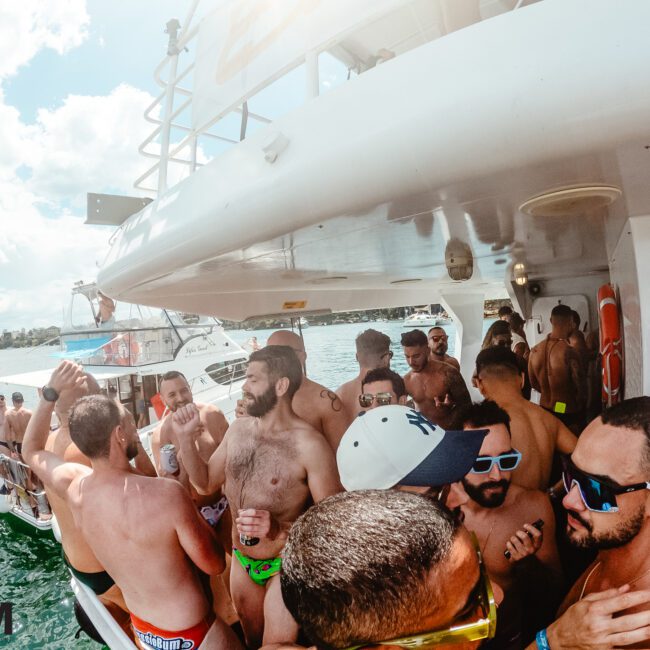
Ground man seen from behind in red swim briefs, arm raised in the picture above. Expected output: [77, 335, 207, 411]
[24, 361, 240, 649]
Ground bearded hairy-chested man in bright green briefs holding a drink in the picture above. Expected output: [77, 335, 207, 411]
[173, 345, 341, 648]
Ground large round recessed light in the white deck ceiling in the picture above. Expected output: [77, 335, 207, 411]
[519, 185, 622, 217]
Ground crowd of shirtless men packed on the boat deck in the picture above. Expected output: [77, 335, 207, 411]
[13, 305, 650, 650]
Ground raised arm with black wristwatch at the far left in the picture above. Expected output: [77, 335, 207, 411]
[23, 361, 87, 498]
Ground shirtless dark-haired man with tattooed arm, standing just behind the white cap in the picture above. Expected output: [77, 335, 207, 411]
[402, 330, 471, 429]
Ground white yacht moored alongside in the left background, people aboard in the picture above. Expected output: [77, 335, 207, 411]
[0, 282, 248, 536]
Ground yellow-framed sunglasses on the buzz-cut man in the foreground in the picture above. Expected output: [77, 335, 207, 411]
[346, 533, 497, 650]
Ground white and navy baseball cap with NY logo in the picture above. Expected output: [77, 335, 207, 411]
[336, 405, 488, 491]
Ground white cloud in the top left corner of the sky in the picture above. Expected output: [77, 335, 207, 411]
[0, 0, 90, 77]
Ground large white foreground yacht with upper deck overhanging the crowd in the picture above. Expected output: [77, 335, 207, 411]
[35, 0, 650, 647]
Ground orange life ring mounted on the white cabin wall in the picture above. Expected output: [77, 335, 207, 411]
[598, 284, 623, 406]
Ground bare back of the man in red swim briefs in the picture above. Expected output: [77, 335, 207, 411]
[68, 472, 213, 630]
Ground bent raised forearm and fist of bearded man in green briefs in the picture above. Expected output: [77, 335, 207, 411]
[172, 404, 228, 494]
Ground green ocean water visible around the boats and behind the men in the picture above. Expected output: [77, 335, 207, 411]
[0, 321, 492, 650]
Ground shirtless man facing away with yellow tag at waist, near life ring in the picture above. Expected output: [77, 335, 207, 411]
[528, 305, 586, 433]
